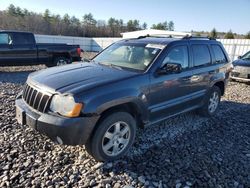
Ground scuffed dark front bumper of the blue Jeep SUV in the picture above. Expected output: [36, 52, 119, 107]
[16, 97, 99, 145]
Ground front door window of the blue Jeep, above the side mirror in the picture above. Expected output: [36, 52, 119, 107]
[161, 46, 188, 69]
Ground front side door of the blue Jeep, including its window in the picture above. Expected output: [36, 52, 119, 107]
[149, 42, 192, 122]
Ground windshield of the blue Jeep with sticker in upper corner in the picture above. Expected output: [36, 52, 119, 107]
[93, 43, 164, 71]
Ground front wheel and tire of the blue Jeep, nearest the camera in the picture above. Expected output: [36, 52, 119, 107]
[85, 112, 136, 162]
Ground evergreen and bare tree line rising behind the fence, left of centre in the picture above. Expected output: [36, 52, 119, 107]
[0, 4, 174, 37]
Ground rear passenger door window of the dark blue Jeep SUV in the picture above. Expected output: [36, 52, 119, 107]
[192, 45, 211, 67]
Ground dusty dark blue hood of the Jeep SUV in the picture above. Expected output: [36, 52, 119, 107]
[27, 63, 138, 94]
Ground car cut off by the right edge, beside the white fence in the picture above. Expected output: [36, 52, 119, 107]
[231, 51, 250, 82]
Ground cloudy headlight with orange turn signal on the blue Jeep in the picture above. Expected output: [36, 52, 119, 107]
[50, 95, 83, 117]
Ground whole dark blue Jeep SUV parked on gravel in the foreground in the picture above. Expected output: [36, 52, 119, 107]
[16, 37, 231, 161]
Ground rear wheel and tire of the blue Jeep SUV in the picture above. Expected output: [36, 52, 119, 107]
[198, 86, 221, 117]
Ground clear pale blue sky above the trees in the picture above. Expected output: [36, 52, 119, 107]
[0, 0, 250, 34]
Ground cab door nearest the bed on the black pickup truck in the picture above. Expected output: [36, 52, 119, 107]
[11, 32, 37, 65]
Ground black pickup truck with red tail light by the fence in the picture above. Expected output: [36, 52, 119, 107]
[0, 31, 81, 67]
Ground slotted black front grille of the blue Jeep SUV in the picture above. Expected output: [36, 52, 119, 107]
[23, 84, 50, 112]
